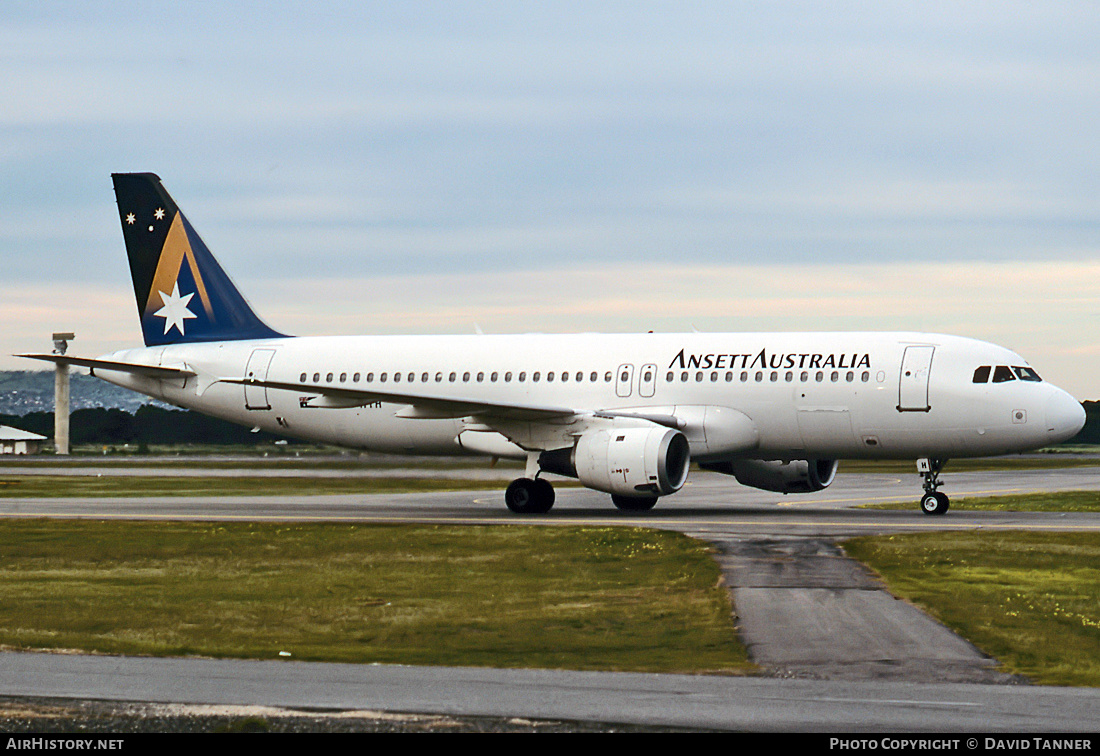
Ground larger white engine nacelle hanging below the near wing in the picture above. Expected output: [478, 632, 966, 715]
[539, 427, 691, 496]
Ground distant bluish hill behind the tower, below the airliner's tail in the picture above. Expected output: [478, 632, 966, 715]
[0, 370, 168, 415]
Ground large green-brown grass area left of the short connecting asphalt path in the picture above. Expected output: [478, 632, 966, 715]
[0, 521, 749, 672]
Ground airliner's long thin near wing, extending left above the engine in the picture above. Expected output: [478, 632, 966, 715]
[222, 379, 578, 420]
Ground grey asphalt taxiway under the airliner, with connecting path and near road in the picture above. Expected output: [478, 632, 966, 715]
[0, 467, 1100, 732]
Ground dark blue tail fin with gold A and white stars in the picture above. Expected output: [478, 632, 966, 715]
[111, 173, 283, 347]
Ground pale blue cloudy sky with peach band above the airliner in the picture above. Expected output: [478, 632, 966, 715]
[0, 0, 1100, 399]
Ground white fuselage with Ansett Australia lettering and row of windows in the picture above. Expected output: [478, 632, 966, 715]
[96, 332, 1082, 461]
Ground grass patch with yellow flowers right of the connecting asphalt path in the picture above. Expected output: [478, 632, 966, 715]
[844, 532, 1100, 687]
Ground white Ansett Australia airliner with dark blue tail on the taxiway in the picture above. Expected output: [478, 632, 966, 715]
[21, 173, 1085, 515]
